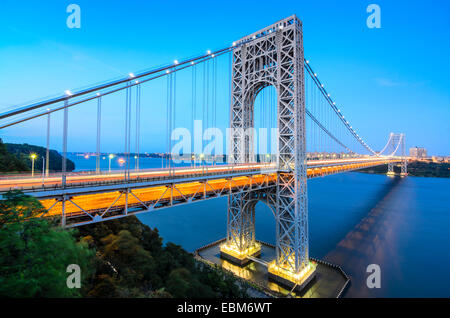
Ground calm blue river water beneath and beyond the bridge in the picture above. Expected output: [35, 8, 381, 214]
[71, 157, 450, 297]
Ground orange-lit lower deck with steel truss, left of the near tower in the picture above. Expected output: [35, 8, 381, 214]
[42, 172, 277, 227]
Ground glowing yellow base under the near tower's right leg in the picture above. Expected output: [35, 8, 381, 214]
[267, 261, 317, 291]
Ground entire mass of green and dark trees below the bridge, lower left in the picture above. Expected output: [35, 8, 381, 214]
[0, 191, 247, 298]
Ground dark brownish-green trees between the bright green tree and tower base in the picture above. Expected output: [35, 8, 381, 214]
[75, 216, 247, 298]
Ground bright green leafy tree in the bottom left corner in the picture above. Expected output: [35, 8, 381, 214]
[0, 191, 94, 297]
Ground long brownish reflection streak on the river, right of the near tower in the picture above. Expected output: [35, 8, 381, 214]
[325, 178, 410, 297]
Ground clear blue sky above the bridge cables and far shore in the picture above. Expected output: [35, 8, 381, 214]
[0, 0, 450, 155]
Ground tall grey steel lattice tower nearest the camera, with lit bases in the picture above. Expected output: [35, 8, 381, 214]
[221, 15, 315, 288]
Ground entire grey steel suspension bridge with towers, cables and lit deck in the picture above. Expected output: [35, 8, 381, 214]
[0, 16, 407, 289]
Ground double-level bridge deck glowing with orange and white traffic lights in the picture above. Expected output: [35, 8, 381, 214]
[0, 157, 400, 226]
